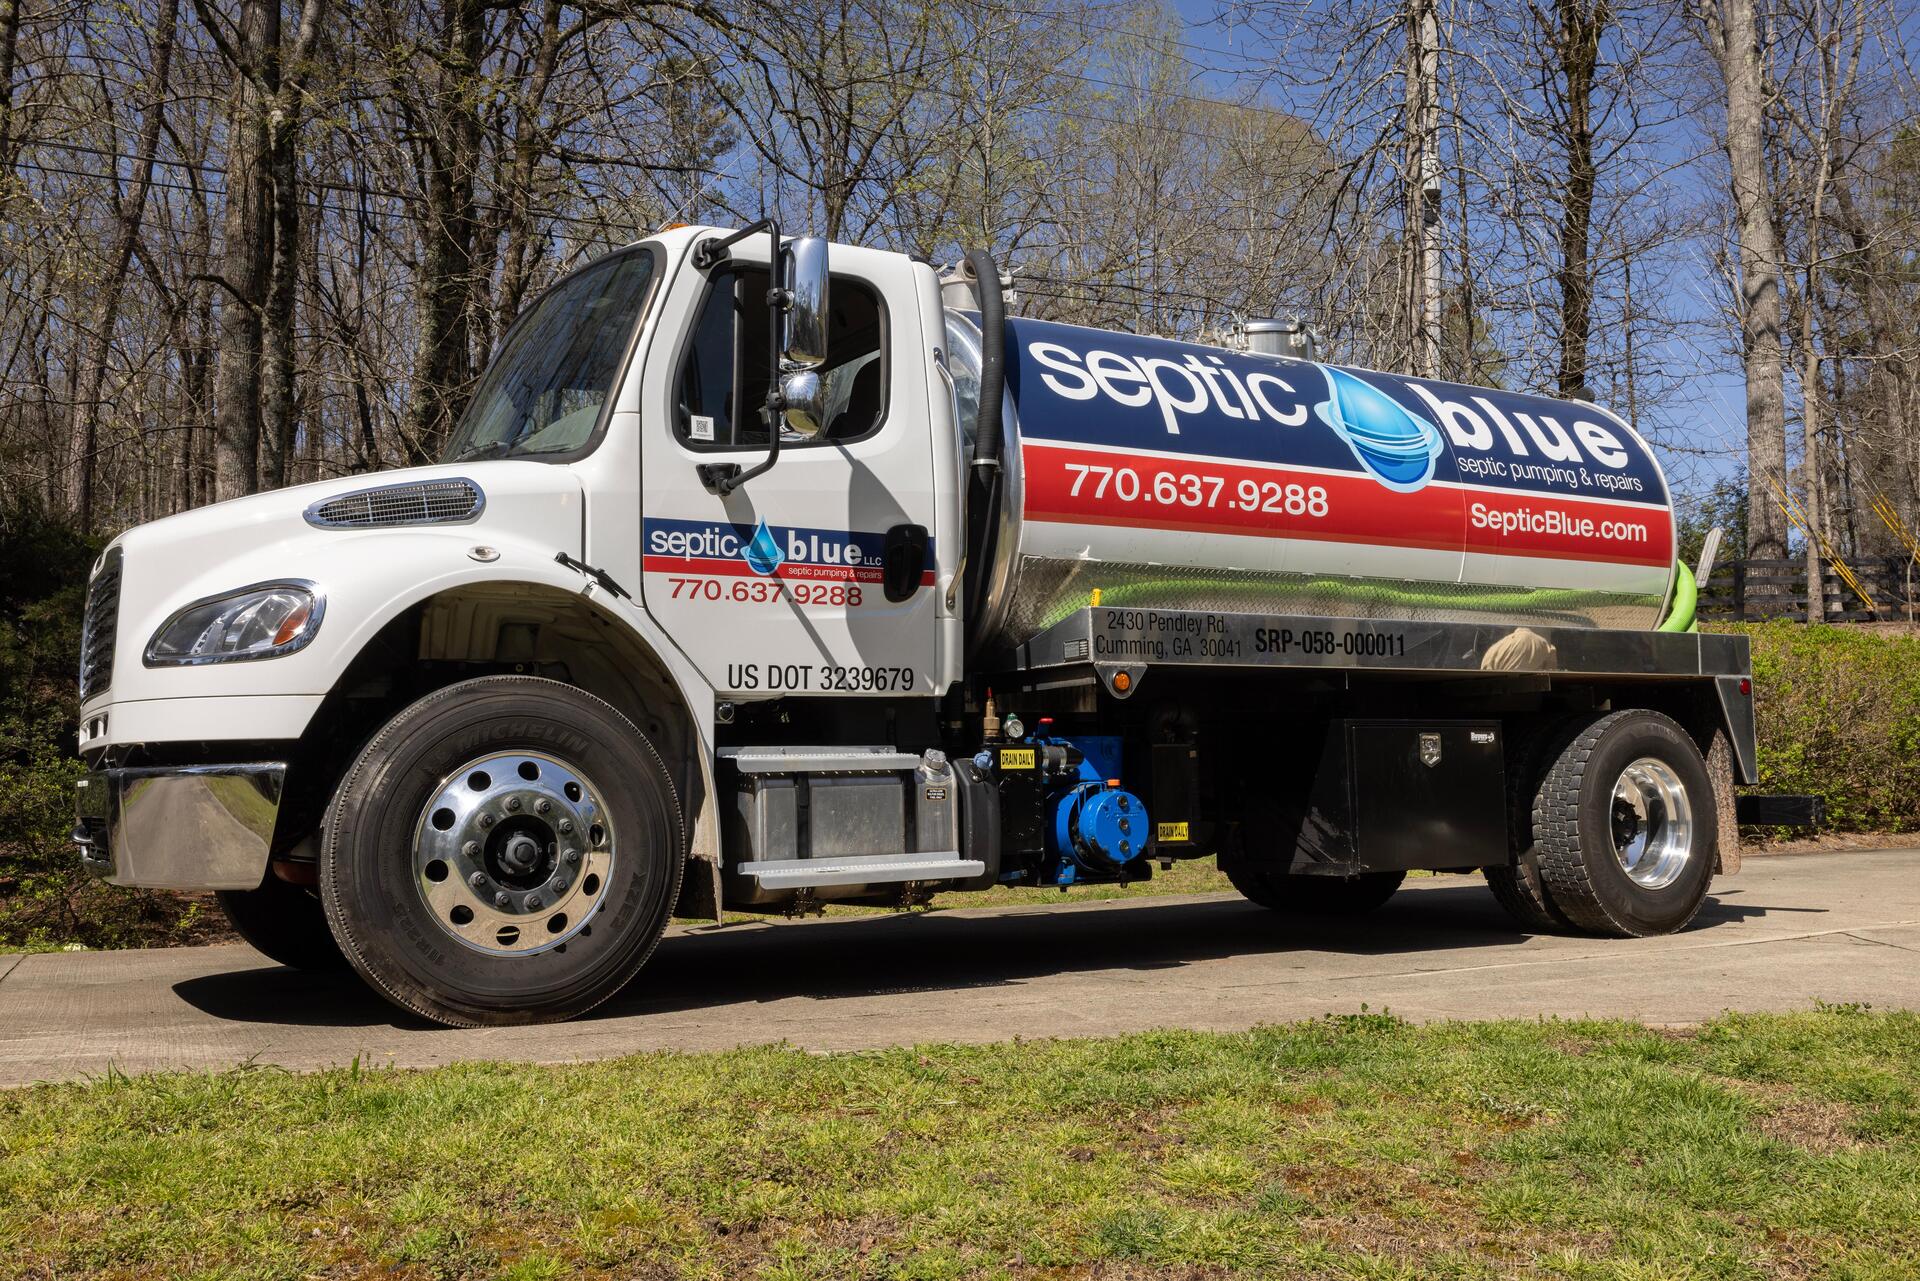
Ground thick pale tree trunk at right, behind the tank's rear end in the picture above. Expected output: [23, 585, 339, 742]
[1707, 0, 1788, 561]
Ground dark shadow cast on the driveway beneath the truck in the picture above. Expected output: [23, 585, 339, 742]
[173, 878, 1805, 1029]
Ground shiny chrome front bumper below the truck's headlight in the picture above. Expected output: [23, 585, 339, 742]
[73, 761, 286, 889]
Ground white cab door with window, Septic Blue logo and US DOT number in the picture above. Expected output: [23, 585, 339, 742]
[641, 236, 939, 699]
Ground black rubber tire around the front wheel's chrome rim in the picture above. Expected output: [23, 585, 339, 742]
[321, 676, 685, 1026]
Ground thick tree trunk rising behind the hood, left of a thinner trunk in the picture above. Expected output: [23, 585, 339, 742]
[202, 0, 280, 499]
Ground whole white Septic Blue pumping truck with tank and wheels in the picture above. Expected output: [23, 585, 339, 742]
[75, 223, 1797, 1026]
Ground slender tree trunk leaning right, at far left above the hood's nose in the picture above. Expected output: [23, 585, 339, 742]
[67, 0, 180, 534]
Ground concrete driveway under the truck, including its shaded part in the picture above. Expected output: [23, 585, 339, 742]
[0, 849, 1920, 1085]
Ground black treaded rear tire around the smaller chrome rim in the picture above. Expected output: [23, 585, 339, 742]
[1532, 709, 1718, 937]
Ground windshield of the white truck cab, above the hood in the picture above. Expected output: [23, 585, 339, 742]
[442, 250, 653, 463]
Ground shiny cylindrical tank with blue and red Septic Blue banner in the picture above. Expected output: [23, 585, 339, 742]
[948, 317, 1676, 649]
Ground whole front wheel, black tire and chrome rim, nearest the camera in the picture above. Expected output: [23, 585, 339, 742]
[319, 676, 685, 1026]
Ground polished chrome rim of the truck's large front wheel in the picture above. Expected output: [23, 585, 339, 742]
[413, 751, 614, 956]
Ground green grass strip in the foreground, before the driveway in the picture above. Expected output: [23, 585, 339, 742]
[0, 1008, 1920, 1281]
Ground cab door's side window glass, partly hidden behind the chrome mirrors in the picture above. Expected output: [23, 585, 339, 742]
[674, 267, 887, 447]
